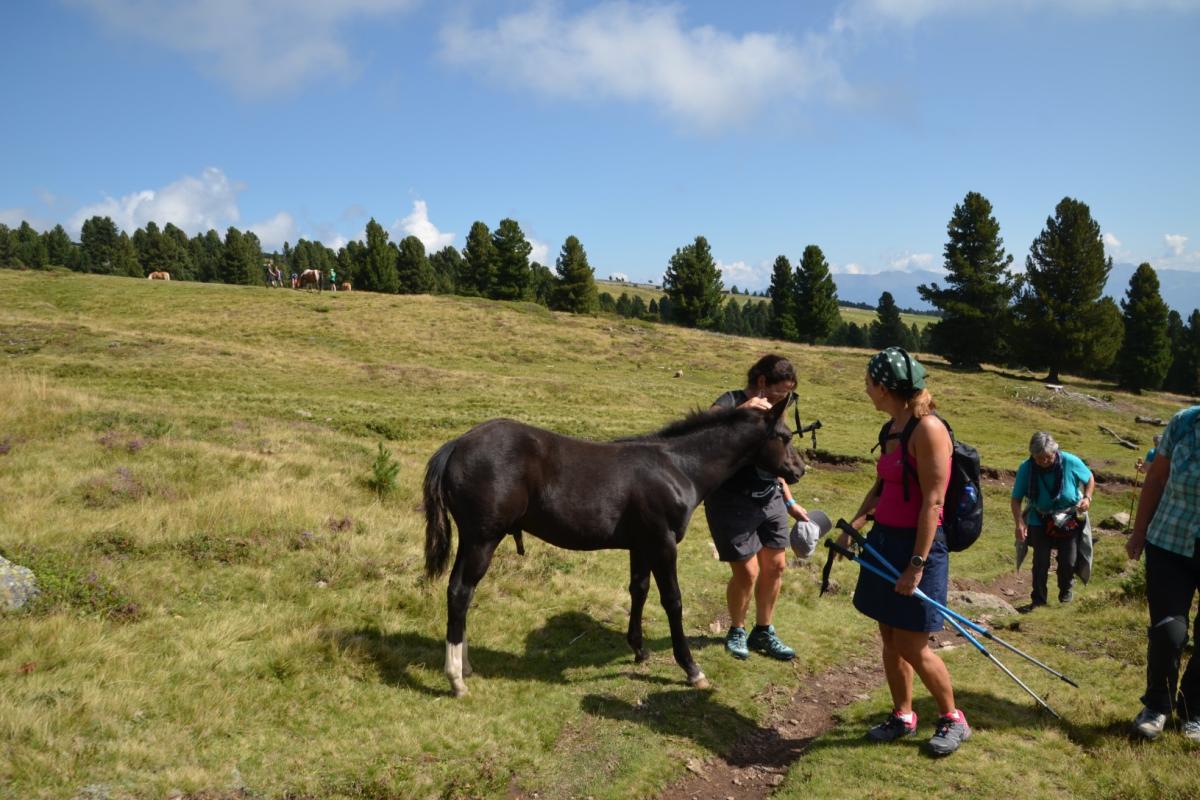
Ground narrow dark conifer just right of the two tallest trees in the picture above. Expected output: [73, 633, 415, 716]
[1117, 264, 1171, 392]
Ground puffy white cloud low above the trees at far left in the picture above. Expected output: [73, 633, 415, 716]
[68, 167, 242, 234]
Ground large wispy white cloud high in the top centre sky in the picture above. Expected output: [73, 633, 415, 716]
[442, 0, 848, 130]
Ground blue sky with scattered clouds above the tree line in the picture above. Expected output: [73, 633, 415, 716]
[0, 0, 1200, 288]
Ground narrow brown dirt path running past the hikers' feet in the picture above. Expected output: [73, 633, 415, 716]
[659, 567, 1030, 800]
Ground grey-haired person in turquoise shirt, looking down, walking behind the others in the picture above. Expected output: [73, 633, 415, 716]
[1010, 431, 1096, 608]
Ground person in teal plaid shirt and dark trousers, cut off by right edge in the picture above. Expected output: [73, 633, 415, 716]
[1126, 405, 1200, 744]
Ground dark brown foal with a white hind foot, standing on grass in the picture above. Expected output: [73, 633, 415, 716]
[425, 399, 804, 697]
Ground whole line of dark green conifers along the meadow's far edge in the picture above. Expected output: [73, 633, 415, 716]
[0, 192, 1200, 395]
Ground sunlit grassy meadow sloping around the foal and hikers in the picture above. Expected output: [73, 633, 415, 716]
[0, 271, 1200, 800]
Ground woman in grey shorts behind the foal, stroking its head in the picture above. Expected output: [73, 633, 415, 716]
[704, 355, 809, 661]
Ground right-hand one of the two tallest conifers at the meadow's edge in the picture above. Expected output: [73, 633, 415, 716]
[1013, 197, 1120, 383]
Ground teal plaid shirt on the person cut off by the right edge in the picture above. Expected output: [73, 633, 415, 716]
[1146, 405, 1200, 558]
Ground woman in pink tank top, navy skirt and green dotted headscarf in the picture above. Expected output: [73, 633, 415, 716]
[839, 347, 971, 756]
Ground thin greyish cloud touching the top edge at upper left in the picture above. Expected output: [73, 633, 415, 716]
[73, 0, 416, 97]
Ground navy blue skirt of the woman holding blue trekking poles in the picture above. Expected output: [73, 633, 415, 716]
[854, 523, 950, 633]
